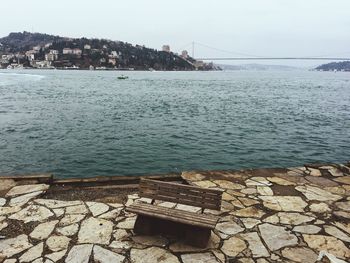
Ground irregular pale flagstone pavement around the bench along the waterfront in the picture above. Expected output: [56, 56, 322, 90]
[0, 164, 350, 263]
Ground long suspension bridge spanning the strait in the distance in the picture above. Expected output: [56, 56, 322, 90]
[181, 42, 350, 61]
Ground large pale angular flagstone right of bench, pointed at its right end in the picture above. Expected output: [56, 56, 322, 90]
[258, 223, 298, 251]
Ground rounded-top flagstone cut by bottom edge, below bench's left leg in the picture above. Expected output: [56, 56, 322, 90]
[130, 247, 179, 263]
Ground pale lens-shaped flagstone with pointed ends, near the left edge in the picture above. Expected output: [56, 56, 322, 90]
[9, 205, 54, 223]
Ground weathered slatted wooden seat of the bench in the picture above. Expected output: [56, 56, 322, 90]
[127, 205, 218, 228]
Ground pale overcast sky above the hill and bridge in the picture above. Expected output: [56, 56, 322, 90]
[0, 0, 350, 66]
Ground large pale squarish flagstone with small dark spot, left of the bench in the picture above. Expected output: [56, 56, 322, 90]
[78, 217, 113, 245]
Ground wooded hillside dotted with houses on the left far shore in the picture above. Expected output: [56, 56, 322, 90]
[0, 32, 202, 70]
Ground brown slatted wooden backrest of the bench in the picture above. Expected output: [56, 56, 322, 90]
[139, 179, 222, 211]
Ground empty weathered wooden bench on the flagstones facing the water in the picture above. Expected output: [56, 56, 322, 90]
[126, 179, 222, 247]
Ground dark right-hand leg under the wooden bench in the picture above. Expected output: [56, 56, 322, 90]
[185, 226, 211, 248]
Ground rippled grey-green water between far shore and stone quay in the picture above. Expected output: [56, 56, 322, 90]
[0, 70, 350, 177]
